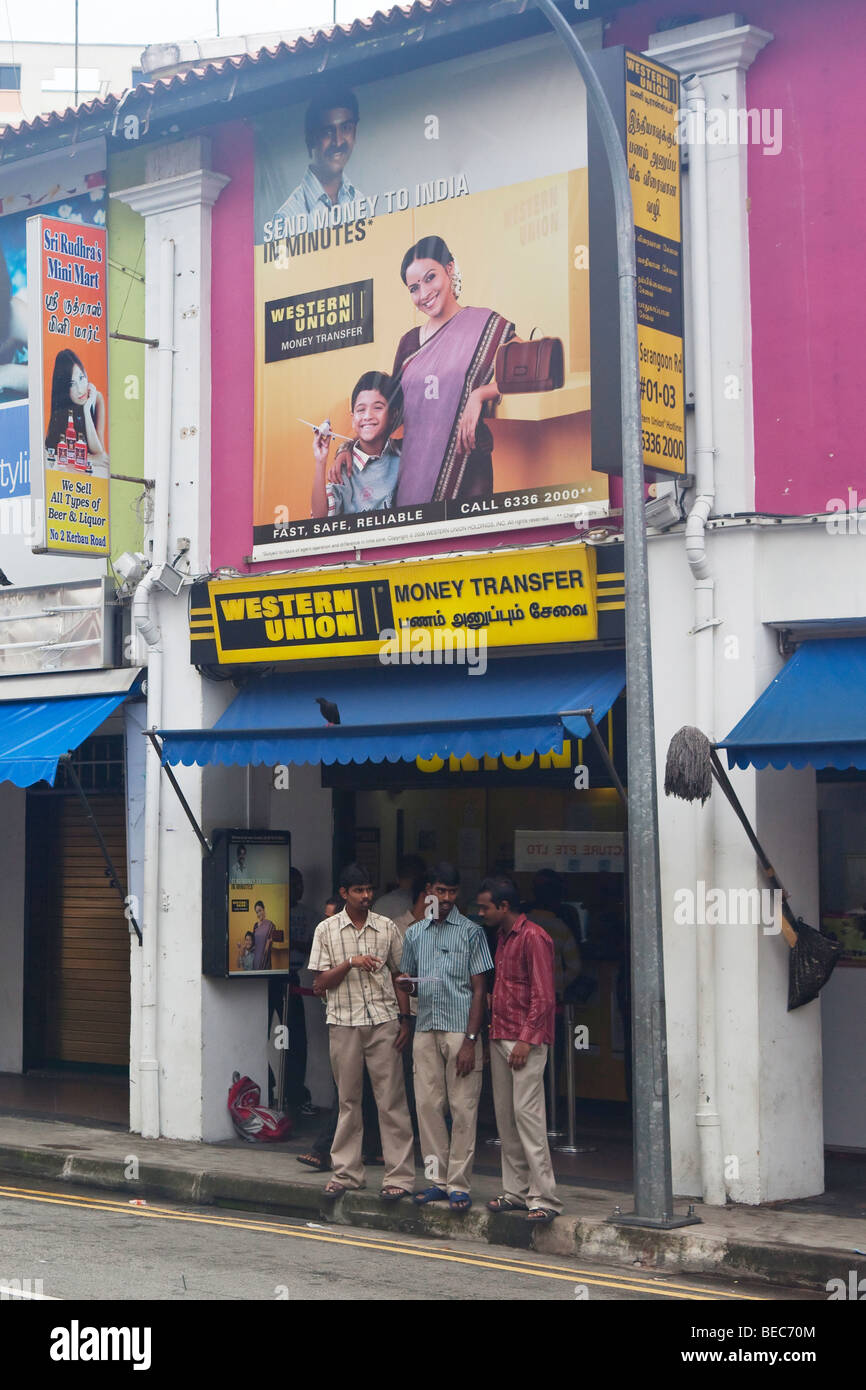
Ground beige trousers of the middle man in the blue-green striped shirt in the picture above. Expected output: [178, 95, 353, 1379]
[414, 1029, 484, 1193]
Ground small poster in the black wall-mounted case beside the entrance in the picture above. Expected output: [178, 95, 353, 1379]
[227, 838, 289, 976]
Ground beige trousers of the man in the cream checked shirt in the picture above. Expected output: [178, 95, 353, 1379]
[329, 1019, 416, 1193]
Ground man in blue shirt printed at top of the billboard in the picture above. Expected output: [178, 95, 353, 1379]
[274, 89, 366, 229]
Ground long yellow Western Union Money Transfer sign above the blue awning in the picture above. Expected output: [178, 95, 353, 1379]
[190, 545, 598, 664]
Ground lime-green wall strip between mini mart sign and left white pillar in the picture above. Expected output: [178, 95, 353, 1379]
[107, 150, 150, 559]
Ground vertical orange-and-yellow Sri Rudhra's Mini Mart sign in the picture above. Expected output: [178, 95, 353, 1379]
[26, 217, 108, 556]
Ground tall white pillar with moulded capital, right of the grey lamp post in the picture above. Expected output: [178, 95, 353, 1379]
[648, 15, 823, 1202]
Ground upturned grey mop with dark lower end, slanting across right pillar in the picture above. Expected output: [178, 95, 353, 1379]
[664, 724, 841, 1012]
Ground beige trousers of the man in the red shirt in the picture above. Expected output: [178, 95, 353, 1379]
[491, 1038, 563, 1212]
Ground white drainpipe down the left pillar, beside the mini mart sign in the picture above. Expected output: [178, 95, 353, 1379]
[132, 239, 175, 1138]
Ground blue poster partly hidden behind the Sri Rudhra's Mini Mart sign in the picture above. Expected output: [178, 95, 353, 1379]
[0, 171, 106, 503]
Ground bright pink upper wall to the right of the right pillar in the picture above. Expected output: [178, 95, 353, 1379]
[605, 0, 866, 514]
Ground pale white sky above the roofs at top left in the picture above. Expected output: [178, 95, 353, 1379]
[0, 0, 391, 47]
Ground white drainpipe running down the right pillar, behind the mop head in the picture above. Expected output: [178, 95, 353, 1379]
[683, 74, 726, 1207]
